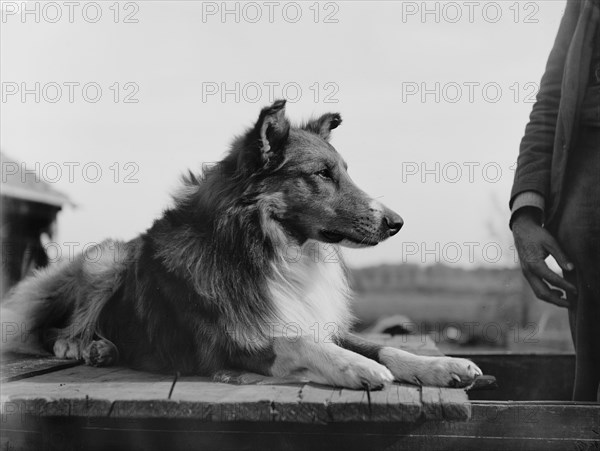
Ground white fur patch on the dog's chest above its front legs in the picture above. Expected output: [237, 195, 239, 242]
[267, 241, 352, 340]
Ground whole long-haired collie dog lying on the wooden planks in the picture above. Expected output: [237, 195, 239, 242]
[2, 100, 481, 388]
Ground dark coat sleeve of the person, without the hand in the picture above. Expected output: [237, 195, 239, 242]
[510, 0, 582, 208]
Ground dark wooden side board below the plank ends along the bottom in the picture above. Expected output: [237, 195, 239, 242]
[0, 402, 600, 451]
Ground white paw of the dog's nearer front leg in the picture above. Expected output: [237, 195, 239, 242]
[331, 355, 394, 390]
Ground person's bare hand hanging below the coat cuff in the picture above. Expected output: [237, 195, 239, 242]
[512, 207, 577, 307]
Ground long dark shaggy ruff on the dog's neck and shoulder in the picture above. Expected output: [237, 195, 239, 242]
[149, 147, 296, 347]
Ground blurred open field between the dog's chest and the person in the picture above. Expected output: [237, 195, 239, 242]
[354, 292, 573, 353]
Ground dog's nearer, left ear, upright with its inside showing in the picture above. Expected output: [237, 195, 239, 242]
[252, 100, 290, 165]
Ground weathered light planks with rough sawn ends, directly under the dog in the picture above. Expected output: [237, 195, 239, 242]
[2, 336, 470, 424]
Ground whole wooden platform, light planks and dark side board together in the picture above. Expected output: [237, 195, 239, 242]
[0, 336, 600, 451]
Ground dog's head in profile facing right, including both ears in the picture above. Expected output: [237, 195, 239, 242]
[231, 100, 403, 247]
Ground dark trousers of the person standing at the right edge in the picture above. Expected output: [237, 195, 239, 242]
[557, 119, 600, 401]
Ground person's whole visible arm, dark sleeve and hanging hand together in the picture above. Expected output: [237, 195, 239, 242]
[510, 0, 581, 307]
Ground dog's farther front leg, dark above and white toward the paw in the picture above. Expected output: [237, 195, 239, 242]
[339, 334, 482, 387]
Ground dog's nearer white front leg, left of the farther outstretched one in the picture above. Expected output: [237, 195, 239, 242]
[270, 336, 394, 389]
